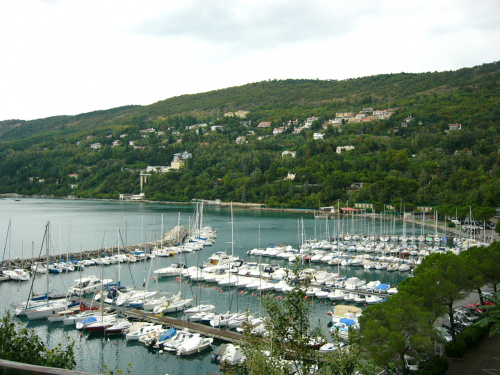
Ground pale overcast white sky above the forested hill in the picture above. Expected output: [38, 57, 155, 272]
[0, 0, 500, 120]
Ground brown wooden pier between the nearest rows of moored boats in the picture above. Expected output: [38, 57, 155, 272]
[122, 309, 242, 342]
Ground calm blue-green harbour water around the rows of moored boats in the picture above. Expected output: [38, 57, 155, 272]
[0, 198, 420, 375]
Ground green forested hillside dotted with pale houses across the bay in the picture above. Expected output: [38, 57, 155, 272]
[0, 63, 500, 220]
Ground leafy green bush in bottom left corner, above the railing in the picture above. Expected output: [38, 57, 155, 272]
[0, 311, 76, 370]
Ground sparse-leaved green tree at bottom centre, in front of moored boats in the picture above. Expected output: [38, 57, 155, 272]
[241, 267, 373, 375]
